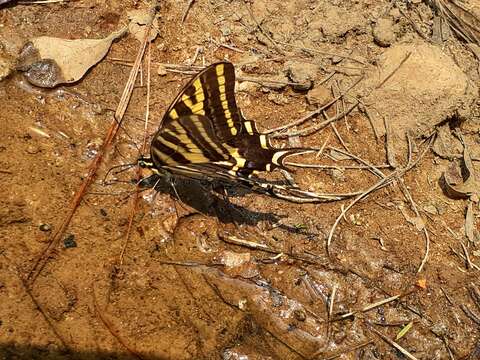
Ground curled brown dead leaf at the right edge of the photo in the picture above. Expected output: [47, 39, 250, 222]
[443, 144, 480, 199]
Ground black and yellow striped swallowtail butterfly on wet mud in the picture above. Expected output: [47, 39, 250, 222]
[137, 61, 325, 202]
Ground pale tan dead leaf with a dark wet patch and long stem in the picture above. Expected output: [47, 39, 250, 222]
[17, 28, 126, 88]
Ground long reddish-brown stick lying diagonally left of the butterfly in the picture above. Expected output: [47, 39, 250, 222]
[27, 18, 151, 287]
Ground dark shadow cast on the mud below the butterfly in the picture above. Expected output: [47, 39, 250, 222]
[140, 174, 316, 236]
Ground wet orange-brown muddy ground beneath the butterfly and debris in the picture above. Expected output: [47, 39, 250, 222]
[0, 0, 480, 359]
